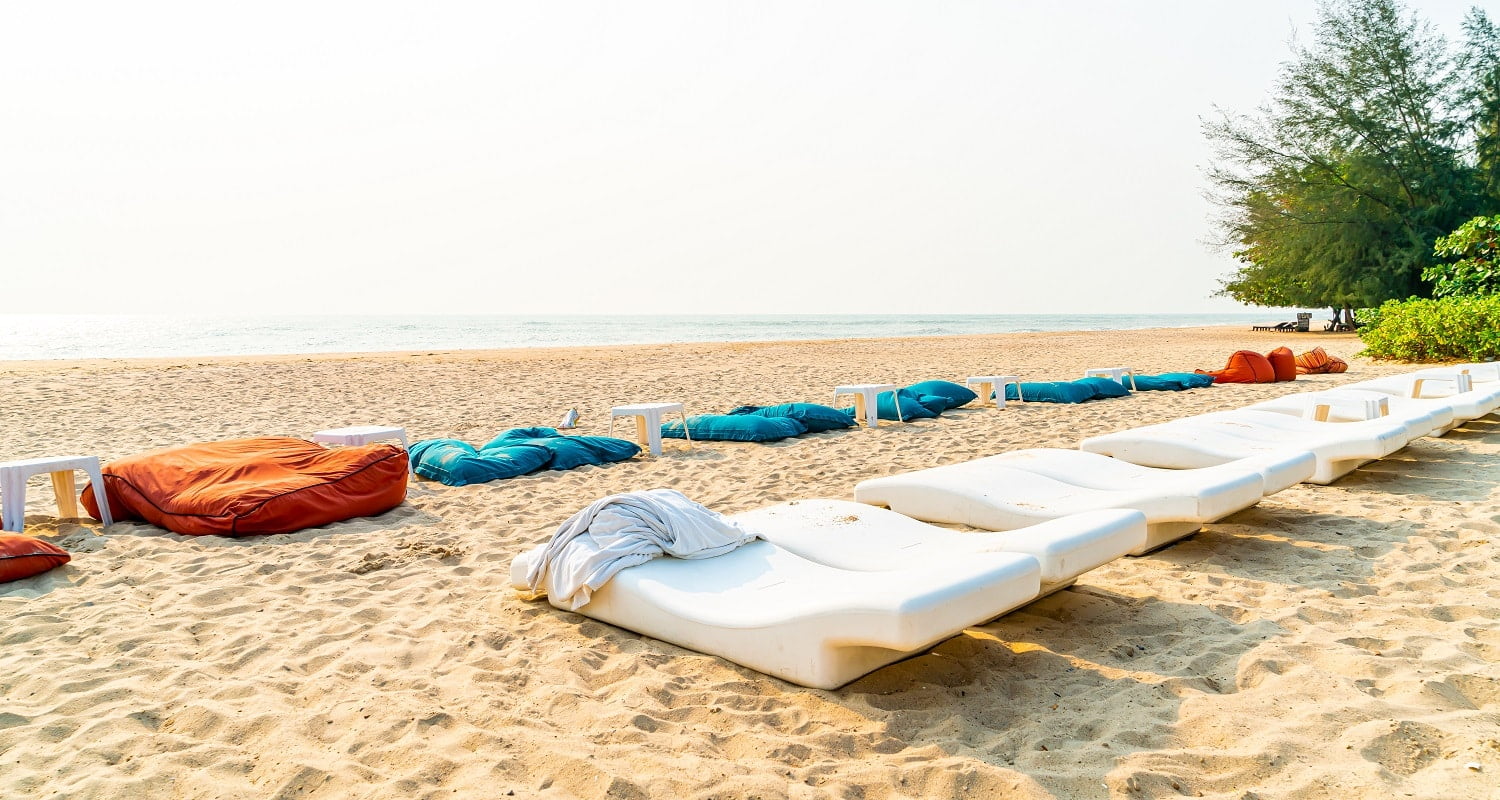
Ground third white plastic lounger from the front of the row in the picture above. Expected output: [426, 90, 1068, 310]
[854, 456, 1265, 555]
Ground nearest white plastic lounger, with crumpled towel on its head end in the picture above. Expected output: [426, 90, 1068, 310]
[510, 542, 1041, 689]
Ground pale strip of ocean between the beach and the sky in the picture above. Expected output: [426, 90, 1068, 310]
[0, 312, 1292, 360]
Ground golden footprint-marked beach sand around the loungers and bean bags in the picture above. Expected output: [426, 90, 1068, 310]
[0, 329, 1500, 800]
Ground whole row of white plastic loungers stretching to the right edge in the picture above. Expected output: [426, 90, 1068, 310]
[512, 363, 1500, 689]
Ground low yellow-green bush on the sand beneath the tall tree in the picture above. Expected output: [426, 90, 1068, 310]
[1359, 294, 1500, 362]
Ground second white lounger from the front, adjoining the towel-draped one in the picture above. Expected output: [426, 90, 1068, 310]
[731, 500, 1146, 591]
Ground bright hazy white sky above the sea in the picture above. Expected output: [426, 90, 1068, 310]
[0, 0, 1470, 314]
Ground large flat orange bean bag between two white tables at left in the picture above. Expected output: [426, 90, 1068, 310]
[83, 437, 407, 536]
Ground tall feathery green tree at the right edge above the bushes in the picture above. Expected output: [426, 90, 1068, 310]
[1205, 0, 1500, 306]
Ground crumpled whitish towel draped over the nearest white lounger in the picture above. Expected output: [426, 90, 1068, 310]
[522, 489, 759, 611]
